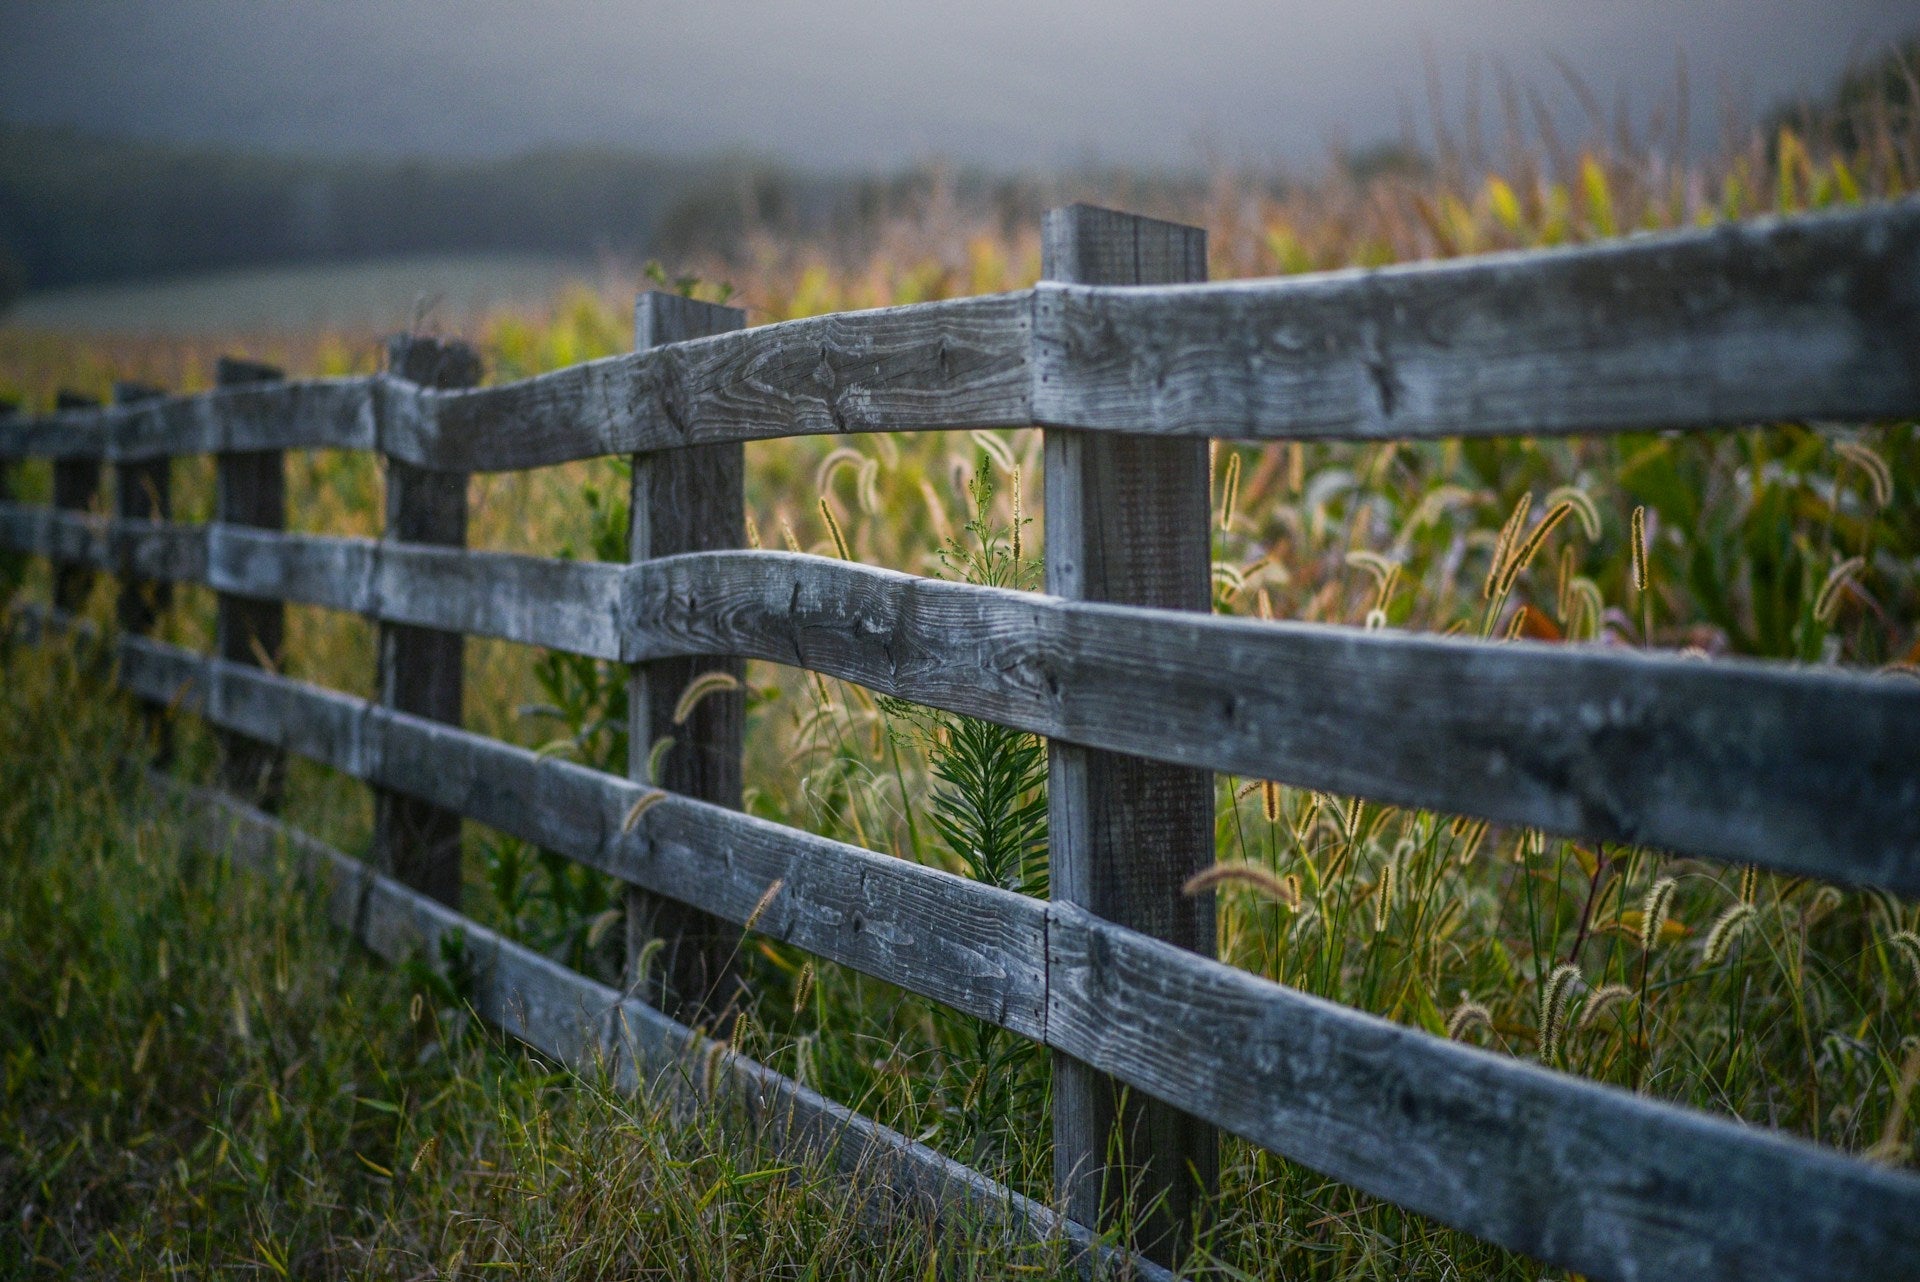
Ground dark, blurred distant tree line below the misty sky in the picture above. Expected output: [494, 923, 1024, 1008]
[0, 125, 1228, 305]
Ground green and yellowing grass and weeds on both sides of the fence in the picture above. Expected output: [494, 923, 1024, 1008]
[0, 67, 1920, 1278]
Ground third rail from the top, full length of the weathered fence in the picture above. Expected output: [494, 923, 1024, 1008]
[7, 610, 1920, 1278]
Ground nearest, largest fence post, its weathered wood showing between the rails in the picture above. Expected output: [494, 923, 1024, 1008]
[1043, 205, 1219, 1265]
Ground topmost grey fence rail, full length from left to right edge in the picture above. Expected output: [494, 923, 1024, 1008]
[0, 200, 1920, 472]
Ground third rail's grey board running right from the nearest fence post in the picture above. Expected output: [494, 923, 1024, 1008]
[1046, 904, 1920, 1282]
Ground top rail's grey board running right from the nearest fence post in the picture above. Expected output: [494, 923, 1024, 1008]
[1033, 200, 1920, 439]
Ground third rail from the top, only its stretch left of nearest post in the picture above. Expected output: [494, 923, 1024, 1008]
[119, 637, 1044, 1038]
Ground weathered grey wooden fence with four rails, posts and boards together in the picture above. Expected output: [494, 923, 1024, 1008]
[0, 202, 1920, 1278]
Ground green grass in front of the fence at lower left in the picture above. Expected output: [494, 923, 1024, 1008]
[0, 649, 1098, 1278]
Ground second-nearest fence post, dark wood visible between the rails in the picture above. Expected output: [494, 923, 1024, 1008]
[628, 292, 747, 1029]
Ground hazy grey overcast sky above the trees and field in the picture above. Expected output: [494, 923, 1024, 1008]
[0, 0, 1920, 169]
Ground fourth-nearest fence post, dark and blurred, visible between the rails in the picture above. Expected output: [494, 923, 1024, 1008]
[213, 357, 286, 814]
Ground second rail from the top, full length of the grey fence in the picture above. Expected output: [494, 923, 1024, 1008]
[0, 505, 1920, 894]
